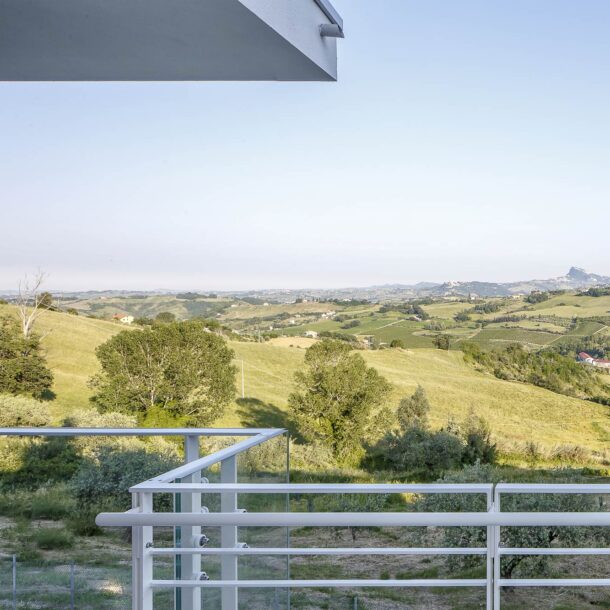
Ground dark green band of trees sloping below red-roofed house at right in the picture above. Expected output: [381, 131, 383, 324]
[462, 342, 610, 404]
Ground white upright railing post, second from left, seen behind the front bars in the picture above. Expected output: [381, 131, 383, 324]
[178, 435, 201, 610]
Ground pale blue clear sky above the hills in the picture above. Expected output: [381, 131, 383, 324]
[0, 0, 610, 290]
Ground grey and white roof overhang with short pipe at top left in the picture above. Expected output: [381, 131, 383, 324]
[0, 0, 343, 81]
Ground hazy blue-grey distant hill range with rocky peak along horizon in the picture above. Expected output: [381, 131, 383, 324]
[0, 267, 610, 303]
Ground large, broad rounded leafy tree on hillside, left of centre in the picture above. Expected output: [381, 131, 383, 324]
[91, 321, 236, 425]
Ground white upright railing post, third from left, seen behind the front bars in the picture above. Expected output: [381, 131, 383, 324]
[220, 456, 238, 610]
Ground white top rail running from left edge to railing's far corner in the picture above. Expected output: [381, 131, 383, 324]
[0, 428, 284, 436]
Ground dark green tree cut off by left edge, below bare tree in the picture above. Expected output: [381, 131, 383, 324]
[0, 316, 53, 398]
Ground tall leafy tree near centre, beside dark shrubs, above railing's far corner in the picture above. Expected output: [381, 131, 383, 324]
[289, 340, 391, 465]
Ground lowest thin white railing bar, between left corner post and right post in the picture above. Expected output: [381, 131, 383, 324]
[150, 578, 487, 589]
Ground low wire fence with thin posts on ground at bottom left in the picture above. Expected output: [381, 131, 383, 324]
[0, 556, 131, 610]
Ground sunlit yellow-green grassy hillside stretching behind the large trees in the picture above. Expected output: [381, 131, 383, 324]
[0, 306, 610, 450]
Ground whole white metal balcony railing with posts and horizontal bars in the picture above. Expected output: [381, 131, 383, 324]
[0, 428, 610, 610]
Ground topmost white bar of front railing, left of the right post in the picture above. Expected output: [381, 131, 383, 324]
[138, 482, 493, 495]
